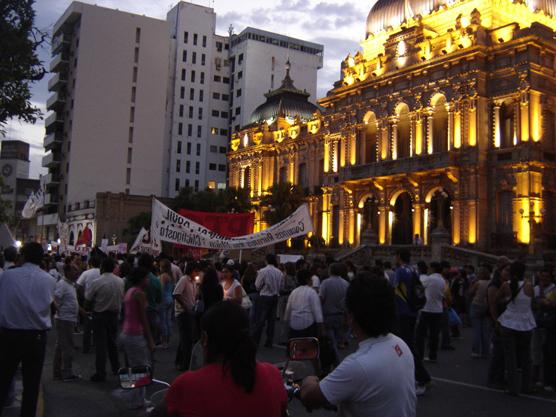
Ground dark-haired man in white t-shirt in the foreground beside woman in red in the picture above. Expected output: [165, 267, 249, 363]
[301, 273, 416, 417]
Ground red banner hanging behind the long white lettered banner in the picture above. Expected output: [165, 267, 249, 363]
[178, 209, 255, 237]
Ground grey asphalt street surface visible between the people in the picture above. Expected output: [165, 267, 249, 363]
[25, 322, 556, 417]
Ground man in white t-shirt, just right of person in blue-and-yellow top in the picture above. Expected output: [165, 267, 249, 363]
[415, 261, 446, 363]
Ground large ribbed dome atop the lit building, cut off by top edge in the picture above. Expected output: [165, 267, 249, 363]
[367, 0, 556, 35]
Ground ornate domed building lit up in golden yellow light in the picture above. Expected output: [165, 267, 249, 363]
[228, 0, 556, 251]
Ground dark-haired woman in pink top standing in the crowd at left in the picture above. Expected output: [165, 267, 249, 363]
[120, 267, 154, 408]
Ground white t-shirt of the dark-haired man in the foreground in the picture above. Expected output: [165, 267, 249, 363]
[320, 334, 416, 417]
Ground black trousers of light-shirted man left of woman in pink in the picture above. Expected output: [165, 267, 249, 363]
[93, 311, 120, 376]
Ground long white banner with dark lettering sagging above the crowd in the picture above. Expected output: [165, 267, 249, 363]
[151, 198, 313, 250]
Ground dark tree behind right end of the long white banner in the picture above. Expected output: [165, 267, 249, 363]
[261, 182, 306, 225]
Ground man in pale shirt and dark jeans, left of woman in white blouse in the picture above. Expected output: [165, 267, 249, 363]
[253, 253, 284, 347]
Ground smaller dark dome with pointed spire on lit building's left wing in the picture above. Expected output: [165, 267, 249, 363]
[250, 61, 319, 123]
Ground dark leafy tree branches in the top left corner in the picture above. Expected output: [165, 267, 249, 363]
[0, 0, 46, 134]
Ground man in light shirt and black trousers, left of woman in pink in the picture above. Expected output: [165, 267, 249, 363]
[85, 258, 124, 382]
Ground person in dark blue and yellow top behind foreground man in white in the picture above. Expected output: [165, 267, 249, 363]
[394, 249, 431, 395]
